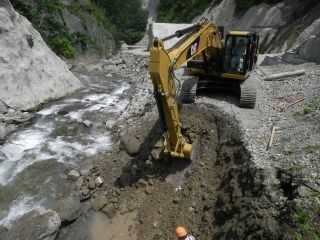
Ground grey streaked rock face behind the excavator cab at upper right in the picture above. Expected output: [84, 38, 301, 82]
[193, 0, 320, 53]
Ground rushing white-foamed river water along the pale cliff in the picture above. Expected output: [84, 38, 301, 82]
[0, 72, 130, 228]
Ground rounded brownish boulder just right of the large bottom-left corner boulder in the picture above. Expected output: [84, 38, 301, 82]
[53, 196, 82, 222]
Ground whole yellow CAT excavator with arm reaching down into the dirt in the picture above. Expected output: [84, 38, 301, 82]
[149, 19, 259, 159]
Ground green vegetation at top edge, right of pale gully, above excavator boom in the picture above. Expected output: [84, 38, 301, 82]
[157, 0, 212, 23]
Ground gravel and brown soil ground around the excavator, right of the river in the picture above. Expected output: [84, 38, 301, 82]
[0, 48, 320, 239]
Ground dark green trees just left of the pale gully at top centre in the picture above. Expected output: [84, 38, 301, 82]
[92, 0, 148, 47]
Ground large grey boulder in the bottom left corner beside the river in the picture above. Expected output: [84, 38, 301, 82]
[4, 208, 61, 240]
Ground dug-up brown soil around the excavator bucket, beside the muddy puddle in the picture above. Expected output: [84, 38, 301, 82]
[93, 104, 295, 239]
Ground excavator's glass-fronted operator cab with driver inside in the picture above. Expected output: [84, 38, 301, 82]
[223, 31, 259, 80]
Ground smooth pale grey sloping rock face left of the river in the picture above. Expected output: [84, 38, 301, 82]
[0, 0, 82, 109]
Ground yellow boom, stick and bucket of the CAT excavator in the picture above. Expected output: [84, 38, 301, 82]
[149, 22, 222, 159]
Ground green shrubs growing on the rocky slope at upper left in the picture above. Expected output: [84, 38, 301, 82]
[11, 0, 108, 58]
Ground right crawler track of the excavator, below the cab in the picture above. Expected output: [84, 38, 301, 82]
[239, 77, 257, 108]
